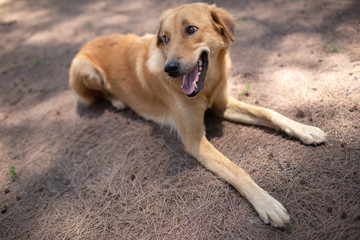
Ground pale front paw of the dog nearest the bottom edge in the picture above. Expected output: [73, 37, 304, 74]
[253, 191, 290, 227]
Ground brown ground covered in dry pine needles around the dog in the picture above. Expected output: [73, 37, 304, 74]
[0, 0, 360, 239]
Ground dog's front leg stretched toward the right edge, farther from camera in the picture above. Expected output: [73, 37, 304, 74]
[214, 97, 326, 144]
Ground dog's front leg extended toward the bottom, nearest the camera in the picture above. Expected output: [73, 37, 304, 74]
[176, 108, 289, 227]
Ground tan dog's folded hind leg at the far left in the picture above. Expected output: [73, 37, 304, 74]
[69, 55, 125, 109]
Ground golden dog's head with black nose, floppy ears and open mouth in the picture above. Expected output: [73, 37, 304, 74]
[156, 3, 235, 97]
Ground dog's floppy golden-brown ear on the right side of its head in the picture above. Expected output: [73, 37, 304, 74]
[210, 4, 235, 42]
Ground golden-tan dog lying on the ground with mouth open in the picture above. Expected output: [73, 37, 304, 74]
[69, 3, 326, 227]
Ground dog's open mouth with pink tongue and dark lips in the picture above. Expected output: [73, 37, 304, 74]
[181, 52, 209, 97]
